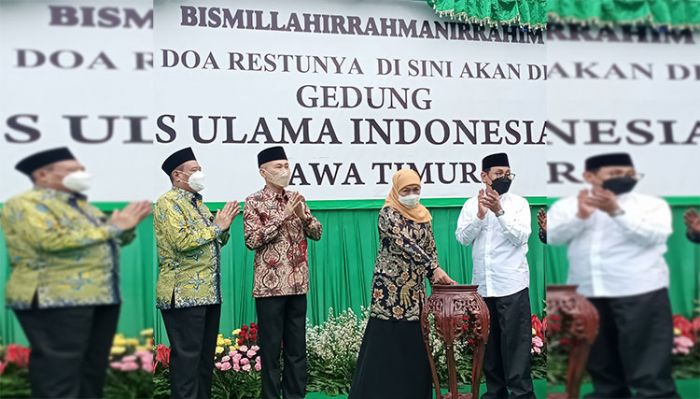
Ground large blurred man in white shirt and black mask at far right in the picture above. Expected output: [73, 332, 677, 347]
[547, 153, 677, 398]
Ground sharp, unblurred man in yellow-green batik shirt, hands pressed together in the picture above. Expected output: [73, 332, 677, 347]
[153, 147, 239, 399]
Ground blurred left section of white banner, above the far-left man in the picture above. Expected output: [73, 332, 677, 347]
[0, 0, 157, 201]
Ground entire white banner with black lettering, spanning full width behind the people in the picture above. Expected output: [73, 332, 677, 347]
[0, 0, 700, 202]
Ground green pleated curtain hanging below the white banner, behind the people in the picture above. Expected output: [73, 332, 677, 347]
[0, 199, 700, 344]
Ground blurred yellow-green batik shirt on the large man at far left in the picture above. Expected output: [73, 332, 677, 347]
[2, 188, 135, 309]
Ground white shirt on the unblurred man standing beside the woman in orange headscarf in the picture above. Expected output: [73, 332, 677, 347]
[455, 193, 531, 297]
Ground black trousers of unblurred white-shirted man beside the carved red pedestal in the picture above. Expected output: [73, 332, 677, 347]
[482, 288, 535, 399]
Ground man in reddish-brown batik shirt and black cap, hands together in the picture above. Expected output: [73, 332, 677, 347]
[243, 147, 322, 399]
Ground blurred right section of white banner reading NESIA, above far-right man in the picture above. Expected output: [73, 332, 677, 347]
[546, 26, 700, 197]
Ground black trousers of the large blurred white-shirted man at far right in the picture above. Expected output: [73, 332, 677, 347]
[586, 288, 678, 398]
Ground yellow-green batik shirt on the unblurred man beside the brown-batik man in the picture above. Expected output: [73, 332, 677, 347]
[153, 188, 229, 309]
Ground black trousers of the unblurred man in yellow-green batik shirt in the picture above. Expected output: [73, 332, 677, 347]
[161, 305, 221, 399]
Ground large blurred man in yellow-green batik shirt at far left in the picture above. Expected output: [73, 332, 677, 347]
[2, 147, 151, 398]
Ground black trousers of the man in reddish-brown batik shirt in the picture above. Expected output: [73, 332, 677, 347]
[255, 295, 306, 399]
